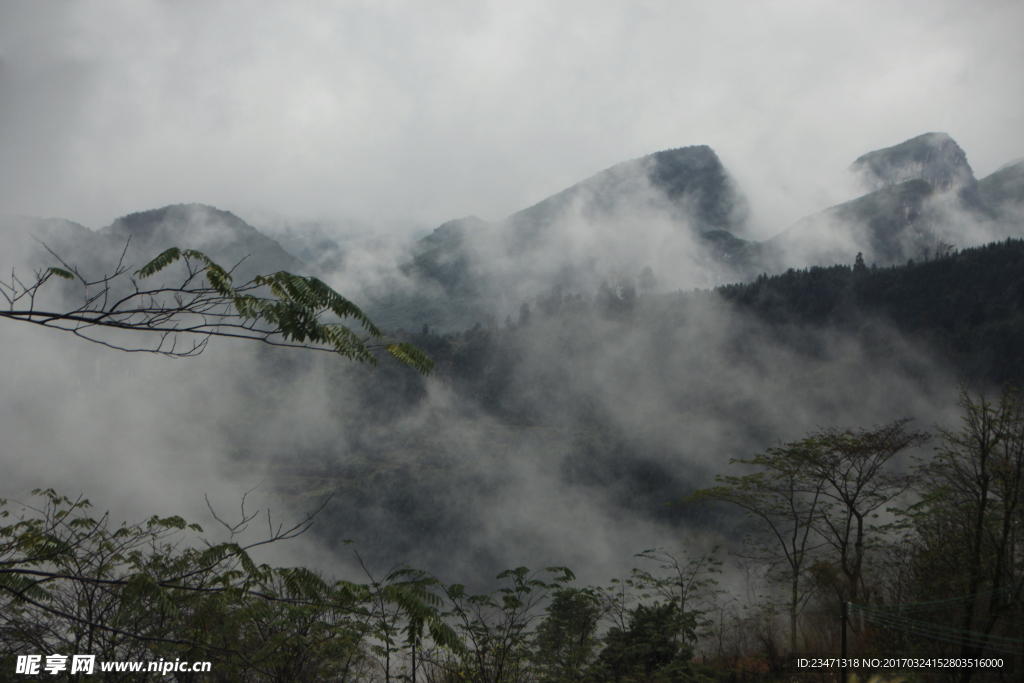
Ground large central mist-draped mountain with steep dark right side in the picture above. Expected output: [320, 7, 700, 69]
[373, 145, 749, 329]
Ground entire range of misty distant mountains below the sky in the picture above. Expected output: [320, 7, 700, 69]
[6, 133, 1024, 337]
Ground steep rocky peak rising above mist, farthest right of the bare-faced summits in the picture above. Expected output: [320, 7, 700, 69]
[850, 133, 978, 193]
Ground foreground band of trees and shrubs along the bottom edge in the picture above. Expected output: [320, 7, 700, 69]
[0, 389, 1024, 683]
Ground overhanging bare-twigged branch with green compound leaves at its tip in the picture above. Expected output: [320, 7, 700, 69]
[0, 245, 434, 374]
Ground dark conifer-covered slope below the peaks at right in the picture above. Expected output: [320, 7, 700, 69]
[717, 240, 1024, 384]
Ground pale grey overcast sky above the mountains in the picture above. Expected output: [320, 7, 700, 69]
[0, 0, 1024, 240]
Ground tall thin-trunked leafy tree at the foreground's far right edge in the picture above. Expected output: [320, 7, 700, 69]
[915, 388, 1024, 683]
